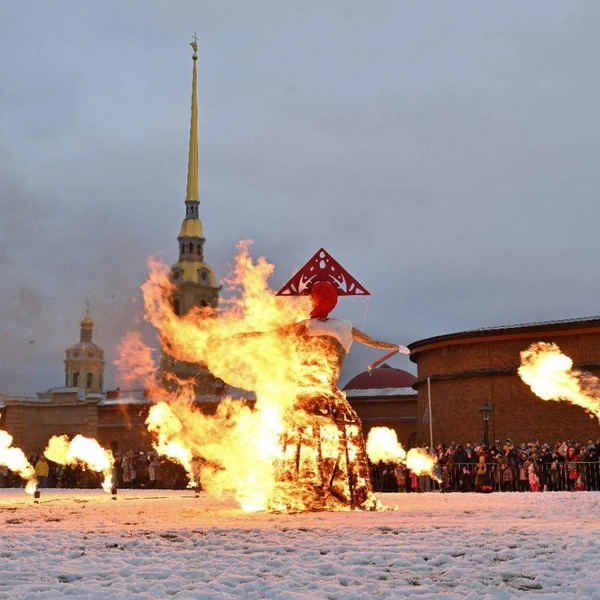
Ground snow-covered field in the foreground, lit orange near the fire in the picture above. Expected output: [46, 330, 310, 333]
[0, 489, 600, 599]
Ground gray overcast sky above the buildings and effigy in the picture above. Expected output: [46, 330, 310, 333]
[0, 0, 600, 394]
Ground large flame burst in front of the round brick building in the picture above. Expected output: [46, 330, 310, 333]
[518, 342, 600, 420]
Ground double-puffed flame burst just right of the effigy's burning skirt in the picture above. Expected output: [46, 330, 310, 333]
[367, 427, 436, 478]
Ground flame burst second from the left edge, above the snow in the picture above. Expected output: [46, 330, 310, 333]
[44, 435, 115, 493]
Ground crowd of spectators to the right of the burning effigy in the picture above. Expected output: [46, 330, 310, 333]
[373, 438, 600, 492]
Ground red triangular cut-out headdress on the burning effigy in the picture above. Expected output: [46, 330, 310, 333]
[277, 248, 371, 296]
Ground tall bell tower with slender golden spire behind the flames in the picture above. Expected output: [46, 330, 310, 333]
[162, 35, 221, 394]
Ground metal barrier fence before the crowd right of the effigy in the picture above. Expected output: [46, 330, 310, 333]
[371, 462, 600, 492]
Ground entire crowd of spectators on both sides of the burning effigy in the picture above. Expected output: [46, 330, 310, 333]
[0, 438, 600, 492]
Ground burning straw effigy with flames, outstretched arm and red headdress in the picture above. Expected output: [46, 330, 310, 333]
[118, 244, 408, 511]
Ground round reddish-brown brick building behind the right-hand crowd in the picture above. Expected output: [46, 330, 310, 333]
[409, 317, 600, 445]
